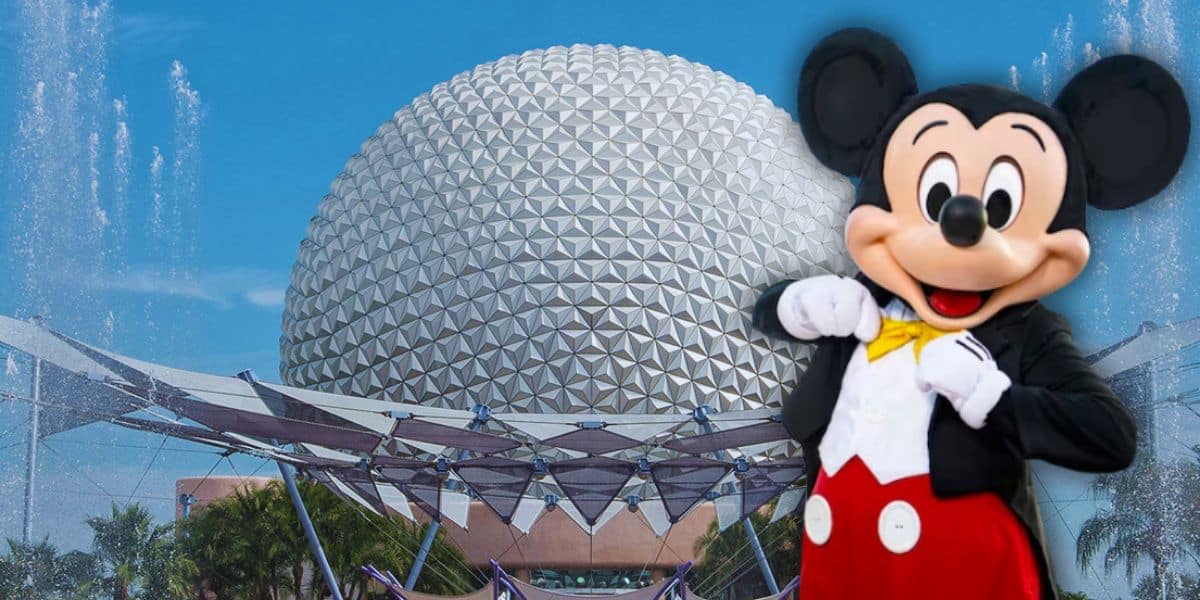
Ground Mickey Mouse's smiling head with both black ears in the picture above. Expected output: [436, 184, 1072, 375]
[799, 29, 1190, 330]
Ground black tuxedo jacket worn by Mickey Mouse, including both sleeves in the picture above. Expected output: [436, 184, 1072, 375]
[754, 276, 1136, 598]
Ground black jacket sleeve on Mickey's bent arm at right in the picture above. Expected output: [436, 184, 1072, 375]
[988, 319, 1136, 473]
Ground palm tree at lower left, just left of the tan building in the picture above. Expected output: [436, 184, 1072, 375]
[88, 503, 170, 600]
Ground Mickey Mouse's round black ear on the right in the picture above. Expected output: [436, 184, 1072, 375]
[1055, 54, 1192, 210]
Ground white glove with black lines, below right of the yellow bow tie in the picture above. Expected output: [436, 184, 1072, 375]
[917, 331, 1013, 430]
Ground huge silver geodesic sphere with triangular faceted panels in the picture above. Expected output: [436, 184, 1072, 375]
[280, 46, 852, 420]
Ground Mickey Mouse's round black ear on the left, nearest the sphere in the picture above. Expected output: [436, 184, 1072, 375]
[798, 29, 917, 176]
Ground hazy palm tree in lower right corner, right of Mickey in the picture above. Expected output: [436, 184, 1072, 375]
[1075, 452, 1200, 598]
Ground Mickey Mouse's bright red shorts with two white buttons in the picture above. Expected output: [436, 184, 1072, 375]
[800, 457, 1040, 600]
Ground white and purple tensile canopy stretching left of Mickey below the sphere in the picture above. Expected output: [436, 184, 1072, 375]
[0, 317, 804, 536]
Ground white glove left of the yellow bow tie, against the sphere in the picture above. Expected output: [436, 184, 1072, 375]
[776, 275, 881, 342]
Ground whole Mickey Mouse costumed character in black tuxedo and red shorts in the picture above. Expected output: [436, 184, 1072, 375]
[754, 29, 1189, 600]
